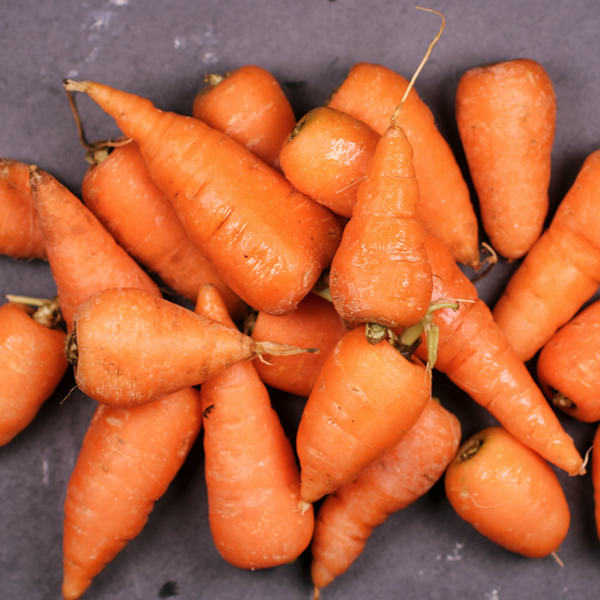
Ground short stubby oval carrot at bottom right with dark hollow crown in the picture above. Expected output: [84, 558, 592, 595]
[445, 427, 571, 558]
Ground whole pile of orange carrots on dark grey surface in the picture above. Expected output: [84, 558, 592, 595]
[0, 11, 600, 600]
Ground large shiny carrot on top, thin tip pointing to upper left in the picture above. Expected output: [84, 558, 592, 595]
[66, 81, 341, 314]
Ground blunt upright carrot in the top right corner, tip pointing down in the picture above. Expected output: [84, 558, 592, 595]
[456, 59, 556, 259]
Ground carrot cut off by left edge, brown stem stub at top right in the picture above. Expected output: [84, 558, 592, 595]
[0, 302, 69, 446]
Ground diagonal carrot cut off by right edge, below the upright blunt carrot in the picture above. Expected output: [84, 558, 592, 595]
[493, 150, 600, 361]
